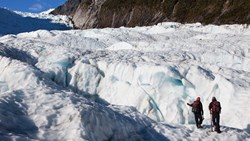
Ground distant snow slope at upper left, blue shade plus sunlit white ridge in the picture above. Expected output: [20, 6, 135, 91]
[0, 7, 73, 35]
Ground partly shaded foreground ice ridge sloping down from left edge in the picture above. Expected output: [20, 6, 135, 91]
[0, 44, 168, 141]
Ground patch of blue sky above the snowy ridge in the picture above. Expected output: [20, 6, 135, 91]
[0, 0, 67, 13]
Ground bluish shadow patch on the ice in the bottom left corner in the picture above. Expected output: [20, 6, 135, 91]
[0, 91, 38, 138]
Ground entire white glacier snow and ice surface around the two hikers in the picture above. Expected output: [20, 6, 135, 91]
[0, 9, 250, 141]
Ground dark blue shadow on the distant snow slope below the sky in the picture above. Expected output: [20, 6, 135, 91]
[0, 8, 71, 35]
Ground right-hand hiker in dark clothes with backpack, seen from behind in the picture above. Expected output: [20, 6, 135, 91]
[208, 97, 221, 133]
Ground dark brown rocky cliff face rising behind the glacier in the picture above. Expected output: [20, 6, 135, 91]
[52, 0, 250, 29]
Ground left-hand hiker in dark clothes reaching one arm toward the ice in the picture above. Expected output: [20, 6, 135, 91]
[187, 97, 204, 128]
